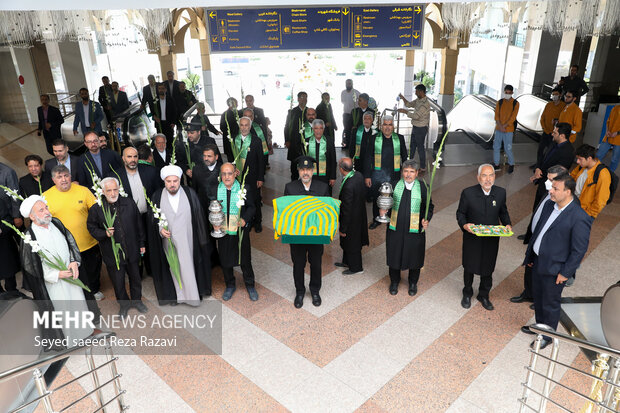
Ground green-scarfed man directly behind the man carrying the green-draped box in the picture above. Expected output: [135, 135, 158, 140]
[307, 119, 336, 196]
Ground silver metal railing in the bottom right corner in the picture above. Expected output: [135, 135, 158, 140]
[519, 324, 620, 413]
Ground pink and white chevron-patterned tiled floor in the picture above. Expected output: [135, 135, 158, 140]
[0, 124, 620, 413]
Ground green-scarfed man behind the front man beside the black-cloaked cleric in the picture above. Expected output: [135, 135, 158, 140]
[233, 117, 265, 232]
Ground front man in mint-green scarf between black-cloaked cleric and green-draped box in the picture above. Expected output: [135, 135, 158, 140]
[209, 163, 258, 301]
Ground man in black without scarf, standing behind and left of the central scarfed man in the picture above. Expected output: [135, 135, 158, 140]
[284, 92, 316, 181]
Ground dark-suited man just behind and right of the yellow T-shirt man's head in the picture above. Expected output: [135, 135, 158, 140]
[77, 132, 123, 191]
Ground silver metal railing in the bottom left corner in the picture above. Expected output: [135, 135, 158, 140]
[0, 333, 129, 413]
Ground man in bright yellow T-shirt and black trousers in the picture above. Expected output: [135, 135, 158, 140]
[43, 165, 103, 300]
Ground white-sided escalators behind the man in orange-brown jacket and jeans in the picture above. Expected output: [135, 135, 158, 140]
[442, 94, 547, 166]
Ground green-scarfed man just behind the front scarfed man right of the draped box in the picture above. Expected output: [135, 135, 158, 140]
[363, 115, 407, 229]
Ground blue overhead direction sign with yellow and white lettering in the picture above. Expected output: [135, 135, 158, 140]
[207, 4, 424, 53]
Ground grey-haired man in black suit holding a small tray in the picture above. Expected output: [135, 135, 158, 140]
[456, 164, 512, 310]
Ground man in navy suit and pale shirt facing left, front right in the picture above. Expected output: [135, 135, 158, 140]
[522, 174, 592, 349]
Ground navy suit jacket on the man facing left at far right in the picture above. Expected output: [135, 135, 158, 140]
[523, 199, 592, 277]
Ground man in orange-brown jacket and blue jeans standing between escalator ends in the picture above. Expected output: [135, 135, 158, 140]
[493, 85, 519, 174]
